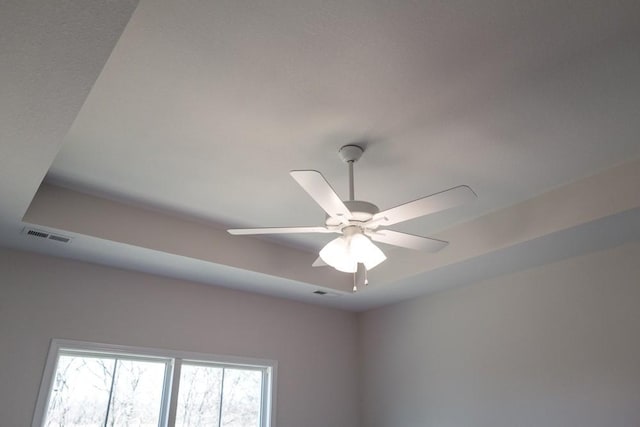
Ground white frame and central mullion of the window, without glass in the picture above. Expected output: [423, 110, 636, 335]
[31, 338, 278, 427]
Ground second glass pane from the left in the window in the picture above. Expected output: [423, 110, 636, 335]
[106, 359, 165, 427]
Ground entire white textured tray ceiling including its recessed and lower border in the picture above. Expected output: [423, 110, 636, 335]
[0, 0, 640, 309]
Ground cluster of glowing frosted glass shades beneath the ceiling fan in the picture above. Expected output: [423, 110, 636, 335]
[320, 233, 387, 273]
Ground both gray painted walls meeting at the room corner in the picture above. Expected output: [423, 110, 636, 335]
[0, 243, 640, 427]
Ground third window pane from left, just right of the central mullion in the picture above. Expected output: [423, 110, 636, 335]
[176, 364, 222, 427]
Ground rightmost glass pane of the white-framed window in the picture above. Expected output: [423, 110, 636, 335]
[220, 369, 262, 427]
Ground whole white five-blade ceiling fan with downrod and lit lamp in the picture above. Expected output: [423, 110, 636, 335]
[227, 144, 477, 273]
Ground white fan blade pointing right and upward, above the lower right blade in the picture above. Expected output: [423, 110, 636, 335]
[369, 185, 478, 229]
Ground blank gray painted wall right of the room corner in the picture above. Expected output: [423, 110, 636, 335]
[360, 243, 640, 427]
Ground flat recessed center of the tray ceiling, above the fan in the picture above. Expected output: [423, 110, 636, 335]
[48, 0, 640, 251]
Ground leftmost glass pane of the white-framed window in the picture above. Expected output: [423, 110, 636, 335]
[44, 356, 114, 427]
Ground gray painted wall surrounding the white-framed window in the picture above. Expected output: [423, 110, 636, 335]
[0, 250, 359, 427]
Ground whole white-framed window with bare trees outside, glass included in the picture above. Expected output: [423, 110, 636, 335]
[33, 340, 276, 427]
